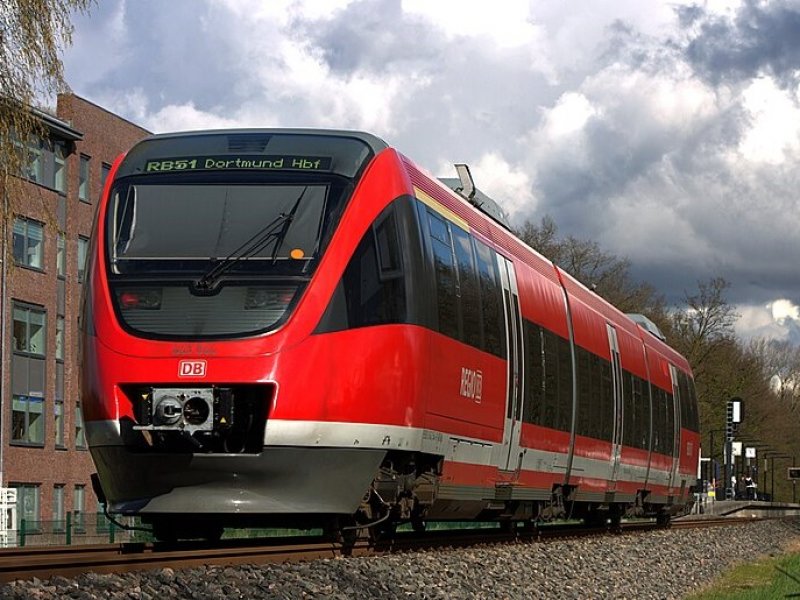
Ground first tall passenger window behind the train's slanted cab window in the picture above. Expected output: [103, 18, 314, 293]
[428, 211, 461, 339]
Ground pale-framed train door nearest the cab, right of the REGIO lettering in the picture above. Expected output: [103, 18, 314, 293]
[497, 254, 523, 471]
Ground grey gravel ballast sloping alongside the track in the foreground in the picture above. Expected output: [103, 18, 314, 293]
[0, 521, 800, 600]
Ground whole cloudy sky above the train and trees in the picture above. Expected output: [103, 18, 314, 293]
[59, 0, 800, 344]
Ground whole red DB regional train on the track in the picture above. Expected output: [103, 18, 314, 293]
[81, 129, 699, 538]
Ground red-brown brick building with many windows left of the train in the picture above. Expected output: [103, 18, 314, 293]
[0, 94, 148, 536]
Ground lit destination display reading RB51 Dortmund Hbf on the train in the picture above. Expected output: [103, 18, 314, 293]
[144, 154, 333, 173]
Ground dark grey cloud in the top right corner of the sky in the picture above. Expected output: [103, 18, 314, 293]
[678, 0, 800, 86]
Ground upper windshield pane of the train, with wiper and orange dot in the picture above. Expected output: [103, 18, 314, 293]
[108, 184, 329, 275]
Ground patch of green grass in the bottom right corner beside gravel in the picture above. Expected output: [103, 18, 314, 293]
[687, 545, 800, 600]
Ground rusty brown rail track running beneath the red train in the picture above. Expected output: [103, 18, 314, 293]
[0, 518, 768, 582]
